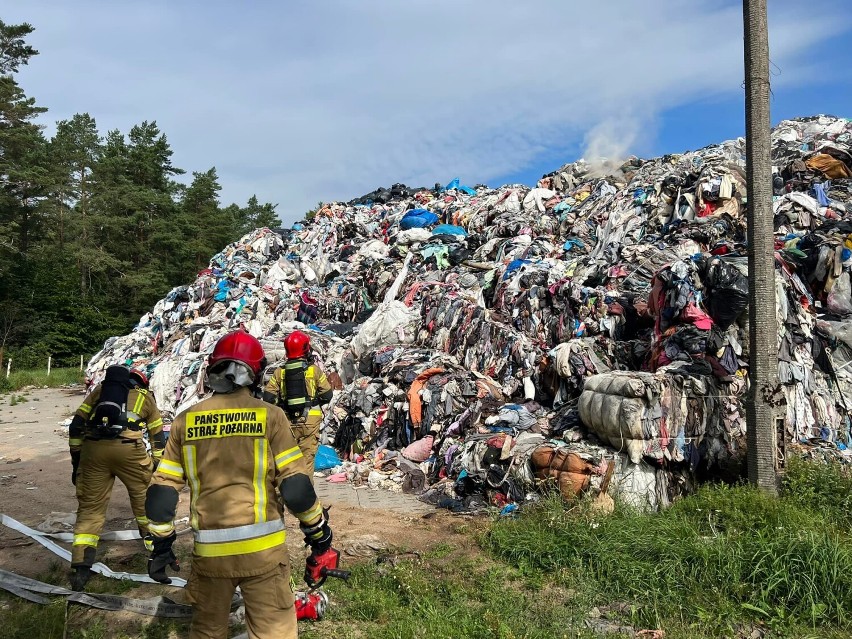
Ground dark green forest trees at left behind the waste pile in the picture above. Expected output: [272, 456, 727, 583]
[0, 20, 280, 368]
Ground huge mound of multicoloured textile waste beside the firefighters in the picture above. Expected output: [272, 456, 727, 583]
[88, 116, 852, 512]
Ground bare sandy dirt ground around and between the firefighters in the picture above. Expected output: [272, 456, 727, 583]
[0, 388, 460, 584]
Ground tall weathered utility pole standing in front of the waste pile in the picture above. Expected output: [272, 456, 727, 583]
[743, 0, 778, 494]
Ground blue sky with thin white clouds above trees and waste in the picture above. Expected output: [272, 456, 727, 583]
[0, 0, 852, 222]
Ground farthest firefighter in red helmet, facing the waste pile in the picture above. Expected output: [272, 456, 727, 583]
[263, 331, 333, 481]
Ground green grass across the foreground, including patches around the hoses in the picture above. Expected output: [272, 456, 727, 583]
[0, 460, 852, 639]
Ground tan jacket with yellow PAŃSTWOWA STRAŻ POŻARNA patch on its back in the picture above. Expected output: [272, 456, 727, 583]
[147, 388, 322, 578]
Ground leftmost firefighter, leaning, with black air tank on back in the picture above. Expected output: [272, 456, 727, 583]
[68, 366, 165, 590]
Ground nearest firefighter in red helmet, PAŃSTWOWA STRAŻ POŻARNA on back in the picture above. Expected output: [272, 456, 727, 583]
[146, 331, 339, 639]
